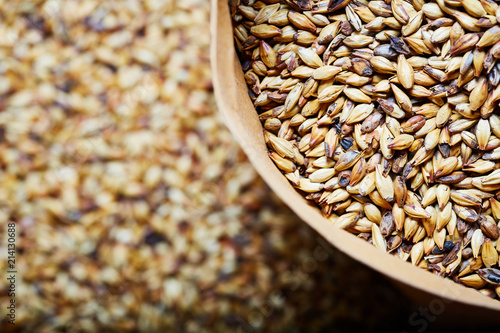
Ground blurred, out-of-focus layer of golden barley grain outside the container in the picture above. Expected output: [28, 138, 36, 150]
[0, 0, 484, 332]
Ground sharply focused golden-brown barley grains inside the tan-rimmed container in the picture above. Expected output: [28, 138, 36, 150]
[230, 0, 500, 298]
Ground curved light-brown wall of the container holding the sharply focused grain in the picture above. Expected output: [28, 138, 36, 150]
[211, 0, 500, 322]
